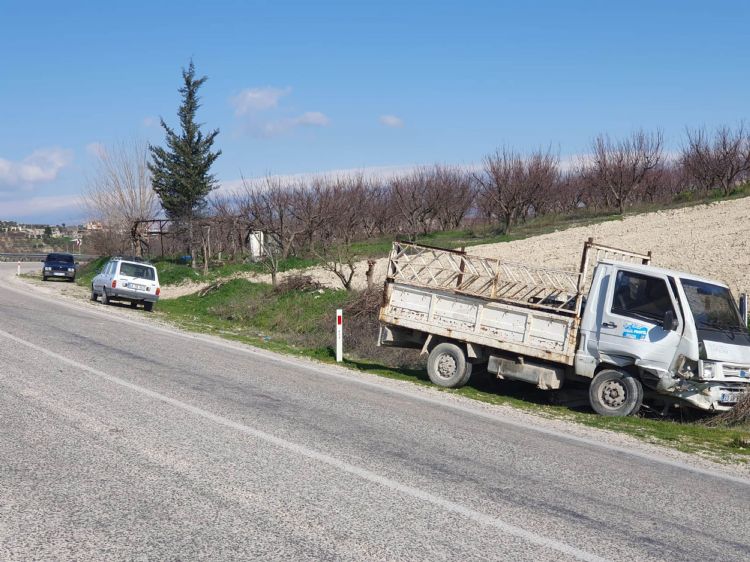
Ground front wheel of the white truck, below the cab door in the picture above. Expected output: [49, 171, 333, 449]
[589, 369, 643, 416]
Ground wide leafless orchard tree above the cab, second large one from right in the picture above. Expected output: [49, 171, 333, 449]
[584, 131, 663, 214]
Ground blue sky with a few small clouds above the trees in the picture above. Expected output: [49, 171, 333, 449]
[0, 0, 750, 222]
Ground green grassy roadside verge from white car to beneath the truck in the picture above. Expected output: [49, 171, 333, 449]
[148, 279, 750, 463]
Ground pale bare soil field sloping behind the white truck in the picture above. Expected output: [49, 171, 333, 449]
[248, 198, 750, 296]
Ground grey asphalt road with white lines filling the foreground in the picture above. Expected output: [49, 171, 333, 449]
[0, 264, 750, 560]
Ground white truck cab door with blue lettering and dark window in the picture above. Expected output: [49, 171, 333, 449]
[598, 267, 683, 373]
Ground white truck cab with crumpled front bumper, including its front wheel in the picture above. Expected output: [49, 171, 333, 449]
[575, 261, 750, 415]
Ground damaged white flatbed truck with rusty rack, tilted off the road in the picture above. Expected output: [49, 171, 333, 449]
[378, 239, 750, 416]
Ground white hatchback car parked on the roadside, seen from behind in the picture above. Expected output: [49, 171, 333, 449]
[91, 258, 161, 311]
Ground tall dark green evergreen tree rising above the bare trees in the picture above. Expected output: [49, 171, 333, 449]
[148, 60, 221, 267]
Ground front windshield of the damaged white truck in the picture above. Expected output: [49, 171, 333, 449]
[680, 279, 745, 330]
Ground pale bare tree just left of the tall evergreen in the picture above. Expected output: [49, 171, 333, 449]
[83, 141, 161, 255]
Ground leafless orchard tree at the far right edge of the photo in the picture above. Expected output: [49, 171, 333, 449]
[680, 123, 750, 196]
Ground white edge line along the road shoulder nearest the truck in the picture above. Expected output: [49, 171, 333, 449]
[5, 277, 750, 486]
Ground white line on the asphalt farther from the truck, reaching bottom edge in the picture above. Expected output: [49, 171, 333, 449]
[0, 330, 606, 562]
